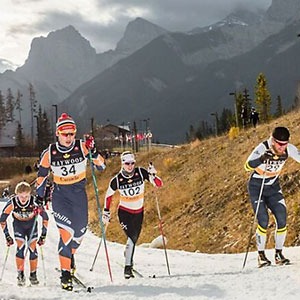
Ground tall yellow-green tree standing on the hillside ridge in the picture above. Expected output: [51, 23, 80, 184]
[255, 73, 271, 122]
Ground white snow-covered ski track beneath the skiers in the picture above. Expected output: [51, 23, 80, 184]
[0, 198, 300, 300]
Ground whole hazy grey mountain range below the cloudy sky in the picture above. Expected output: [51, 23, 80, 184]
[0, 0, 299, 143]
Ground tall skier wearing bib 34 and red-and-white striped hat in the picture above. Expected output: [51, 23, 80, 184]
[36, 113, 105, 291]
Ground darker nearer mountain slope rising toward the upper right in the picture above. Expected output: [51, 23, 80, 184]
[61, 0, 299, 143]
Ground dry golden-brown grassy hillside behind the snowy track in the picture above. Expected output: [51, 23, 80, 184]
[88, 112, 300, 253]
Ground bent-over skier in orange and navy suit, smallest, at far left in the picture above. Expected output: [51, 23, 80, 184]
[0, 181, 48, 286]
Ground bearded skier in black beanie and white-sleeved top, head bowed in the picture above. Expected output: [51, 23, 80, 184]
[245, 127, 300, 267]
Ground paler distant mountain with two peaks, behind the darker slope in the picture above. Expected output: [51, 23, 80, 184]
[0, 18, 166, 127]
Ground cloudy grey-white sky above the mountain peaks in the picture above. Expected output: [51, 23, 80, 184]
[0, 0, 272, 65]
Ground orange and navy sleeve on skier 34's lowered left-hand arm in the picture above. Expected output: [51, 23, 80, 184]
[36, 146, 50, 198]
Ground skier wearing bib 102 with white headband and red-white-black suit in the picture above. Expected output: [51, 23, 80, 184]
[102, 151, 162, 279]
